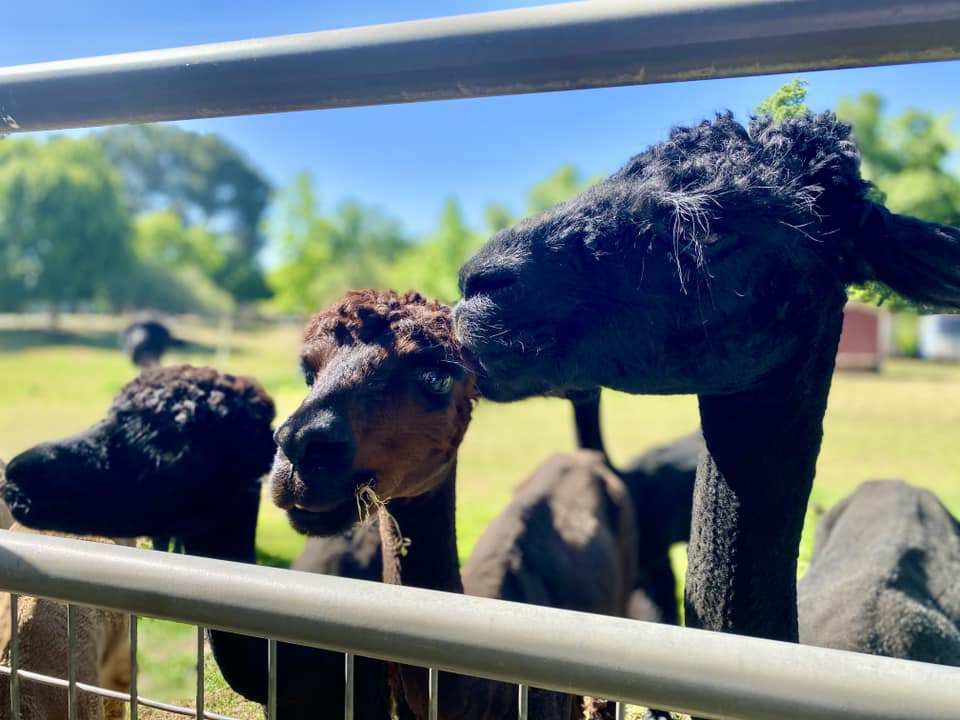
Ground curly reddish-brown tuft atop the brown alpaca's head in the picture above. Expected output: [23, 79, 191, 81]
[303, 290, 460, 365]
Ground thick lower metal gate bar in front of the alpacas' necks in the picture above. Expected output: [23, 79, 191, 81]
[0, 531, 960, 720]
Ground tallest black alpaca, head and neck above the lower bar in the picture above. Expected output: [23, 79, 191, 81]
[456, 108, 960, 660]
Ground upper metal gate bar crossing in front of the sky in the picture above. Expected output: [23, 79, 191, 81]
[0, 0, 960, 132]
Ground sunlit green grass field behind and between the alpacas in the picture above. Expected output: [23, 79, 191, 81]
[0, 316, 960, 718]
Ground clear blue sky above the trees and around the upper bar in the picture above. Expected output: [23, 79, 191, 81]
[0, 0, 960, 238]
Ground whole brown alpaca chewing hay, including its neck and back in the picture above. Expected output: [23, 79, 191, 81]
[272, 290, 633, 720]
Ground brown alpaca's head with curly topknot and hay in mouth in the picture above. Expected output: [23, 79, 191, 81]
[271, 290, 476, 535]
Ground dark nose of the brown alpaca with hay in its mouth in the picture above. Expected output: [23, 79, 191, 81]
[274, 409, 356, 475]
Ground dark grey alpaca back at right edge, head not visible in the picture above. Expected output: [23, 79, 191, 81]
[797, 480, 960, 665]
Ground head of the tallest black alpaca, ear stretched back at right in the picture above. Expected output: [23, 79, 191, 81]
[456, 113, 960, 400]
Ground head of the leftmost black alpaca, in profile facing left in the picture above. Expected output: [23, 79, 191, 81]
[3, 365, 274, 537]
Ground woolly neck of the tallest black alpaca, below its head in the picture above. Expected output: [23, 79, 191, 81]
[686, 312, 842, 642]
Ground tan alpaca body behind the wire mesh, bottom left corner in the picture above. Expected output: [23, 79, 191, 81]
[0, 522, 132, 720]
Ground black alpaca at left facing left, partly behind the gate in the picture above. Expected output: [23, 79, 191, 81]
[4, 366, 389, 720]
